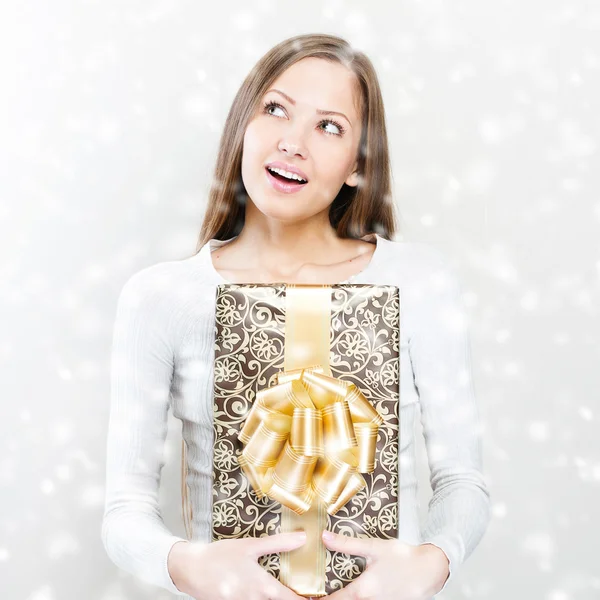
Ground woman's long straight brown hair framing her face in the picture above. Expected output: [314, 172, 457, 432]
[196, 34, 396, 252]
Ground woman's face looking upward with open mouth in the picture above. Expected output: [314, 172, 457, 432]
[242, 57, 361, 222]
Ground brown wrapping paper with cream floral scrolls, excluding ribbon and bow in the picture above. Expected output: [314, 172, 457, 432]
[212, 283, 400, 594]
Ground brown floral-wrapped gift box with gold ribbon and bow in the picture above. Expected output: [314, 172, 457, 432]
[204, 283, 400, 597]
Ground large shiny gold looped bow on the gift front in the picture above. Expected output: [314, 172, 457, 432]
[238, 365, 383, 515]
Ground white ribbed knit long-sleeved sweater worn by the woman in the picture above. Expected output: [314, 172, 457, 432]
[102, 236, 490, 598]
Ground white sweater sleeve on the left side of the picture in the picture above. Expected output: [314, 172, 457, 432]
[101, 267, 186, 596]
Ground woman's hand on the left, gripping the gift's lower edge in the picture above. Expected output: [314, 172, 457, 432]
[167, 532, 306, 600]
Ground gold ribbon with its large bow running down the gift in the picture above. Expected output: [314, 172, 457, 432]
[239, 284, 383, 597]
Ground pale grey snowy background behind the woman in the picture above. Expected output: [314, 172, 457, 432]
[0, 0, 600, 600]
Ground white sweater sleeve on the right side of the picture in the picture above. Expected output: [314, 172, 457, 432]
[408, 245, 490, 591]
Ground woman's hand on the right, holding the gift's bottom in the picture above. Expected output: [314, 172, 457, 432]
[323, 531, 450, 600]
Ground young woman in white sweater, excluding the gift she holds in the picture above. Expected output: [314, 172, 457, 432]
[102, 35, 489, 600]
